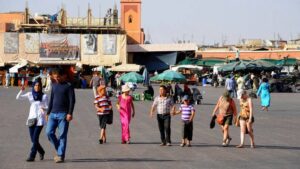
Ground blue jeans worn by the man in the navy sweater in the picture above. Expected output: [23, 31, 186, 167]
[46, 112, 69, 158]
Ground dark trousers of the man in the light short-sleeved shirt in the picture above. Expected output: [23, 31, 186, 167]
[157, 114, 171, 143]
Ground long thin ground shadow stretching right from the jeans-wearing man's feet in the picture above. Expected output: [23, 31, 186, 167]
[68, 158, 177, 163]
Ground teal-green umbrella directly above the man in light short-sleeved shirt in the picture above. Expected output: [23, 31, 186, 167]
[157, 70, 186, 82]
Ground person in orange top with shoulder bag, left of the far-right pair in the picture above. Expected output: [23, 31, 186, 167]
[212, 91, 237, 147]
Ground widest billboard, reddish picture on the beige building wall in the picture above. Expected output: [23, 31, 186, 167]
[40, 34, 80, 60]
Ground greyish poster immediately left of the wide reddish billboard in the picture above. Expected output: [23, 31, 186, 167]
[25, 33, 40, 53]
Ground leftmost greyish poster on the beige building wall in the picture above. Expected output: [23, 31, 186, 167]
[4, 33, 19, 54]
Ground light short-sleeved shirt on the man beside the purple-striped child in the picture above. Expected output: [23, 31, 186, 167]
[152, 96, 174, 114]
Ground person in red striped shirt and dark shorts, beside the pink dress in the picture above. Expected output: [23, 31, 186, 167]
[94, 85, 112, 144]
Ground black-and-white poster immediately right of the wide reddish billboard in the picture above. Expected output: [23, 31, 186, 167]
[82, 34, 98, 55]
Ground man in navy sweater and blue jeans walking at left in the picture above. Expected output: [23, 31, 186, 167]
[46, 70, 75, 163]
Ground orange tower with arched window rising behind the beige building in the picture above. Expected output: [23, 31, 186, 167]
[121, 0, 144, 44]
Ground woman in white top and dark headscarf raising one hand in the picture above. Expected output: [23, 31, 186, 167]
[16, 79, 48, 162]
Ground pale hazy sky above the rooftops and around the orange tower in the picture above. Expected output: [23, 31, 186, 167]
[0, 0, 300, 45]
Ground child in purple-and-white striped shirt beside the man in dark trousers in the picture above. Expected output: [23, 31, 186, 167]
[174, 95, 195, 147]
